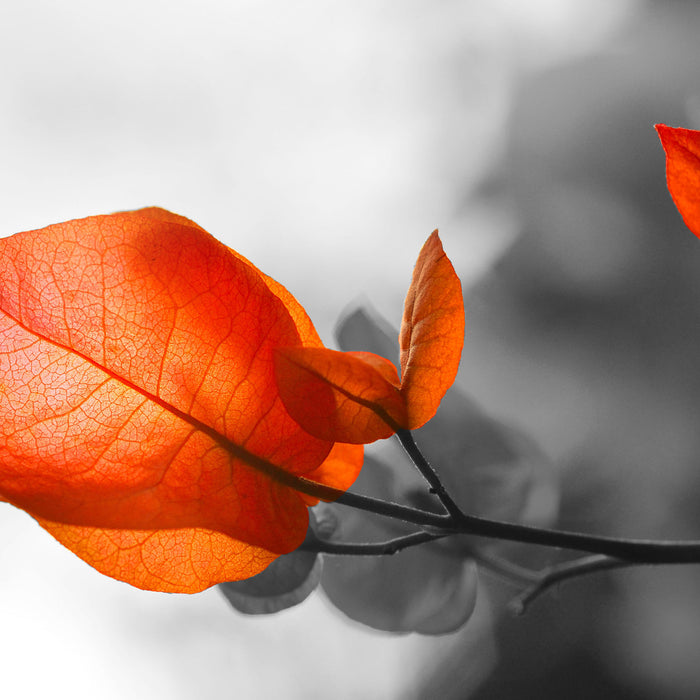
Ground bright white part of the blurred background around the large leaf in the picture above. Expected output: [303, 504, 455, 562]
[0, 0, 636, 700]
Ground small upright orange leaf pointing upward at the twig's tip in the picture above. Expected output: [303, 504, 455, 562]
[399, 231, 464, 430]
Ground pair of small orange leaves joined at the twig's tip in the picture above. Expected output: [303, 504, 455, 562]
[275, 231, 464, 444]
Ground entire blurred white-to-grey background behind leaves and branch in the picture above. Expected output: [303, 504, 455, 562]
[0, 0, 700, 700]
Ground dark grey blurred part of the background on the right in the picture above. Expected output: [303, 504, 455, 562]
[456, 2, 700, 700]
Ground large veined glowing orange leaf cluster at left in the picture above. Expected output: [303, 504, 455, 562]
[0, 209, 361, 591]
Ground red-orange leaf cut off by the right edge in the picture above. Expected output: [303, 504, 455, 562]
[656, 124, 700, 237]
